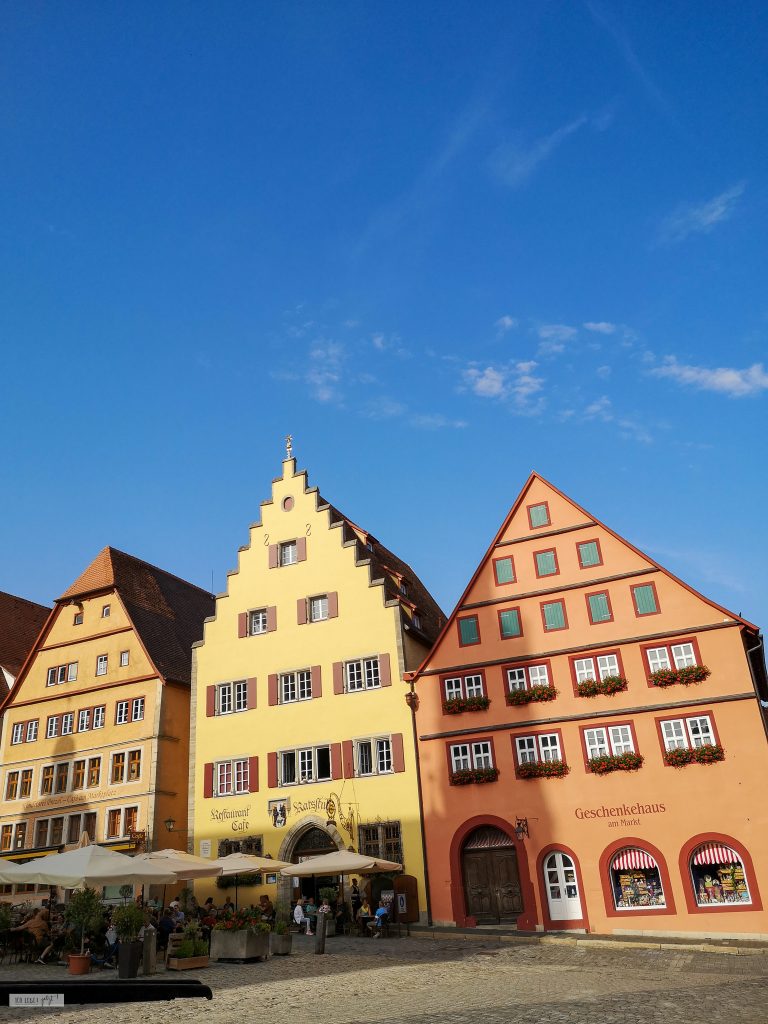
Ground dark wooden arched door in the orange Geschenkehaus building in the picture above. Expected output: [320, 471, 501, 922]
[462, 825, 523, 925]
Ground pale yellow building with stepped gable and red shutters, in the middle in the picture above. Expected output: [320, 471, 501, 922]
[189, 445, 443, 910]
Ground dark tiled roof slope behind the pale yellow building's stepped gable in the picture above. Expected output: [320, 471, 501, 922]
[317, 495, 445, 644]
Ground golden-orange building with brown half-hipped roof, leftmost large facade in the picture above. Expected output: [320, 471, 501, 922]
[0, 548, 214, 895]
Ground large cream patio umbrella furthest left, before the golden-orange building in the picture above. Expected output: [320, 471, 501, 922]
[0, 846, 177, 889]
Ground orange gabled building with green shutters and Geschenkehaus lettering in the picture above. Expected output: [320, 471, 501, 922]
[412, 474, 768, 938]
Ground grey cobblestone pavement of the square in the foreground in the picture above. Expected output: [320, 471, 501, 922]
[0, 936, 768, 1024]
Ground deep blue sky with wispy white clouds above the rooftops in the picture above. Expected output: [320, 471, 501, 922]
[0, 0, 768, 625]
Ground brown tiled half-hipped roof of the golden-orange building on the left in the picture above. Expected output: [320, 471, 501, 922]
[57, 547, 215, 683]
